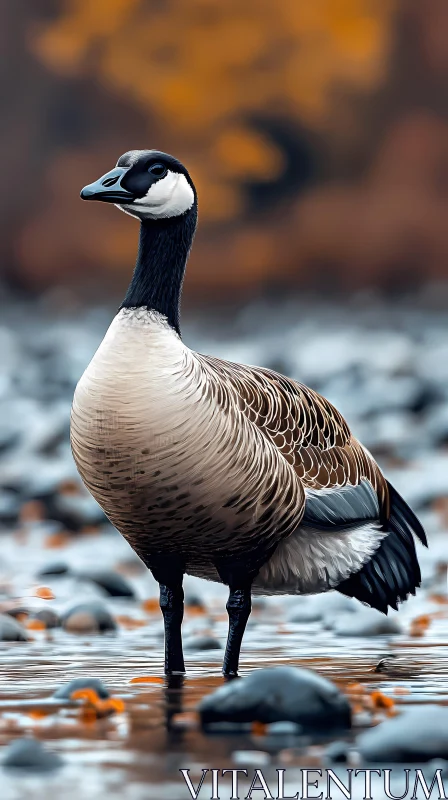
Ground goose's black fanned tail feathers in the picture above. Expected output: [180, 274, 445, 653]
[337, 483, 428, 614]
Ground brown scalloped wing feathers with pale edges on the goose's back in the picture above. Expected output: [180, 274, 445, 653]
[199, 356, 389, 519]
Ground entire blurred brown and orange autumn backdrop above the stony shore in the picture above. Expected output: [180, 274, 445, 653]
[0, 0, 448, 296]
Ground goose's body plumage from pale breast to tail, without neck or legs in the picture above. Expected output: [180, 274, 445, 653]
[71, 308, 424, 606]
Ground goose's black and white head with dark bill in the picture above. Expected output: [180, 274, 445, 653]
[81, 150, 196, 222]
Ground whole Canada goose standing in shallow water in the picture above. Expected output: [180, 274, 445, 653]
[71, 150, 426, 675]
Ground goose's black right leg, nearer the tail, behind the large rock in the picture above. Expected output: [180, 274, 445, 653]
[216, 564, 255, 677]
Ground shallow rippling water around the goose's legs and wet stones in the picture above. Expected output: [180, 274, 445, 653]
[0, 524, 448, 800]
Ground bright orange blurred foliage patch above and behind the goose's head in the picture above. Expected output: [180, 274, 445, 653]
[32, 0, 396, 222]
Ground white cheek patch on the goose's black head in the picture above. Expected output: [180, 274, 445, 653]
[116, 171, 194, 219]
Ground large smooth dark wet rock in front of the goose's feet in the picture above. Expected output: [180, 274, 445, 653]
[199, 667, 351, 732]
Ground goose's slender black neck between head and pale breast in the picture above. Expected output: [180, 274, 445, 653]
[120, 203, 197, 336]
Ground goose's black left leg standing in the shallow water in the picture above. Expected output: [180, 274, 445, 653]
[148, 556, 185, 675]
